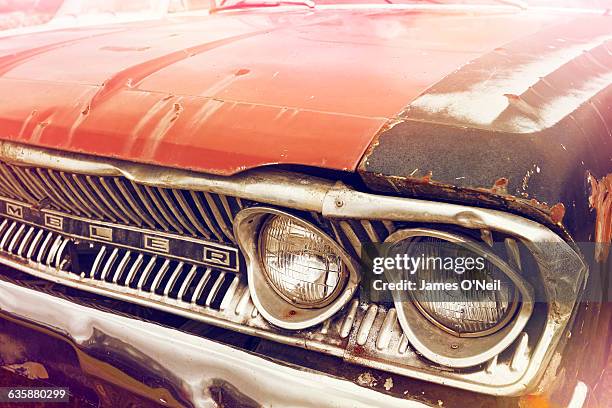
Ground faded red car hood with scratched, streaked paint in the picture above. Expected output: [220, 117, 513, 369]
[0, 7, 580, 175]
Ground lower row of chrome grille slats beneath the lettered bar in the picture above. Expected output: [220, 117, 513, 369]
[0, 218, 239, 309]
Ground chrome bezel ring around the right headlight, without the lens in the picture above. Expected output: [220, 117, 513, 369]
[385, 228, 534, 368]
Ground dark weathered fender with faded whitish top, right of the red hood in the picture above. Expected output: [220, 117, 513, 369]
[360, 17, 612, 241]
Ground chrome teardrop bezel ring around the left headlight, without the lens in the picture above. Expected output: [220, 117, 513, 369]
[234, 207, 360, 330]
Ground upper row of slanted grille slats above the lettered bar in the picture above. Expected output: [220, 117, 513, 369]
[0, 162, 245, 243]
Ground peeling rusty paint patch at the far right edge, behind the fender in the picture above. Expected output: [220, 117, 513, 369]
[587, 173, 612, 262]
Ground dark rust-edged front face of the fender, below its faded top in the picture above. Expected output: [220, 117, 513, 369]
[359, 87, 612, 241]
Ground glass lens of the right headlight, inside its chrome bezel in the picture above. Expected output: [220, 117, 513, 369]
[393, 237, 518, 337]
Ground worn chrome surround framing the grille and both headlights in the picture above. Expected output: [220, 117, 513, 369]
[0, 142, 586, 395]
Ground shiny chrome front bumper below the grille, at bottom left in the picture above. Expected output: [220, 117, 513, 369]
[0, 280, 427, 408]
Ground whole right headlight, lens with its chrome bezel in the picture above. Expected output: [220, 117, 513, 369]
[385, 228, 533, 367]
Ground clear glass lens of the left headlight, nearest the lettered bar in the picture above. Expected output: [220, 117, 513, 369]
[259, 215, 348, 308]
